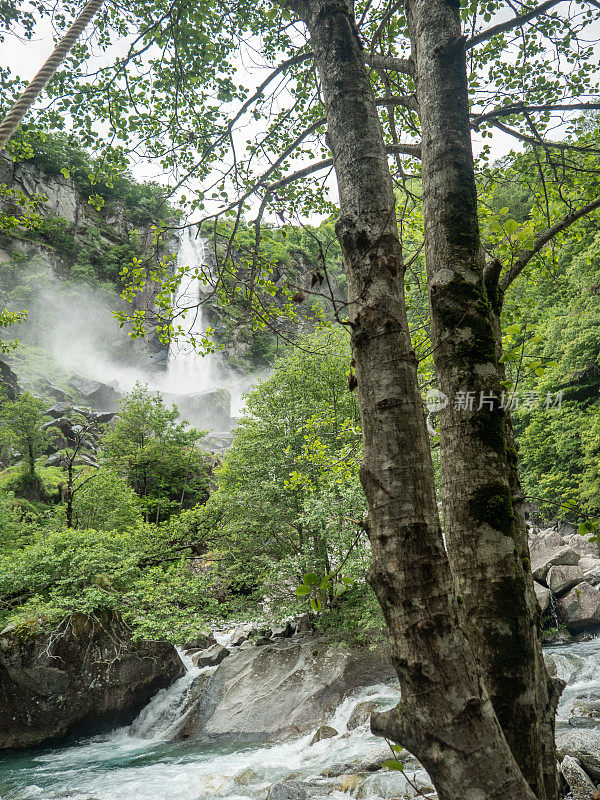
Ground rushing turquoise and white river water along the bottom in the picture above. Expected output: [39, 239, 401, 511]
[0, 638, 600, 800]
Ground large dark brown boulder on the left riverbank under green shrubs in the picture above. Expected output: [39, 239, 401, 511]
[0, 614, 184, 748]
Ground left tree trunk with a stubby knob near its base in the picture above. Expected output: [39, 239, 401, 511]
[290, 0, 533, 800]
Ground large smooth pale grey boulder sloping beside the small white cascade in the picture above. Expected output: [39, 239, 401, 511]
[179, 638, 395, 743]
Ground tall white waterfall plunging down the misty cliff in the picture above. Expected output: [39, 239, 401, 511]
[165, 228, 217, 394]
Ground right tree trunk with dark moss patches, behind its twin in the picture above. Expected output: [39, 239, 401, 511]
[407, 0, 557, 800]
